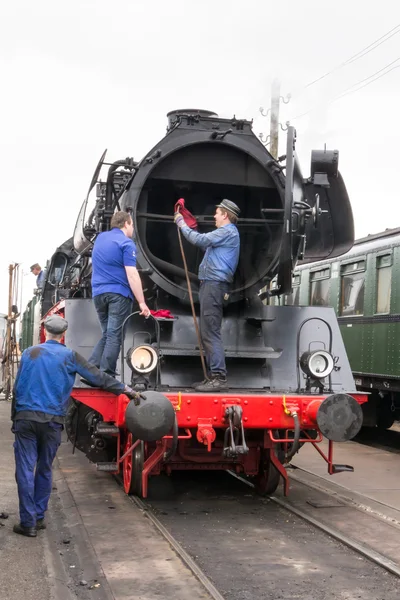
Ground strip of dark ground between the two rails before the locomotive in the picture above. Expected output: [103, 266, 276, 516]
[147, 474, 399, 600]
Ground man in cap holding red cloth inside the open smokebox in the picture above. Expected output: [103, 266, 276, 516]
[174, 199, 240, 392]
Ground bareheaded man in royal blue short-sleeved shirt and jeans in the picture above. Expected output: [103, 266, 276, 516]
[89, 211, 150, 376]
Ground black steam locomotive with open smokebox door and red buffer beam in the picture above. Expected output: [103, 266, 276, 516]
[33, 110, 367, 497]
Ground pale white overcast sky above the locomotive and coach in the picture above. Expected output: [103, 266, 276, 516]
[0, 0, 400, 312]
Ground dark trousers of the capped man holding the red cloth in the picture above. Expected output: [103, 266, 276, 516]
[199, 281, 230, 377]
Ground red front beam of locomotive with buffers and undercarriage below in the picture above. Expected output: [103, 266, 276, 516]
[66, 388, 366, 497]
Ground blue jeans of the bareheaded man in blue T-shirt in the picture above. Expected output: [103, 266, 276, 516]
[89, 292, 132, 375]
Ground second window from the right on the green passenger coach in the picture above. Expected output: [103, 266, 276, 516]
[340, 260, 365, 317]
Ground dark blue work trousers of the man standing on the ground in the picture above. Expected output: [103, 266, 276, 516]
[14, 419, 63, 527]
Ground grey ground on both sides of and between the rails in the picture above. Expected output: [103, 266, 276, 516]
[0, 402, 400, 600]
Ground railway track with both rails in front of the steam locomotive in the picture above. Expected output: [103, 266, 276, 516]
[124, 473, 400, 600]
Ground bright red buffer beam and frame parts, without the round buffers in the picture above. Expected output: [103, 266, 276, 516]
[71, 388, 367, 497]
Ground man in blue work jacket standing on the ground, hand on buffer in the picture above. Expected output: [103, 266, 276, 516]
[11, 315, 139, 537]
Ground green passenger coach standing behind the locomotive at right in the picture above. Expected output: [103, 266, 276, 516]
[280, 228, 400, 429]
